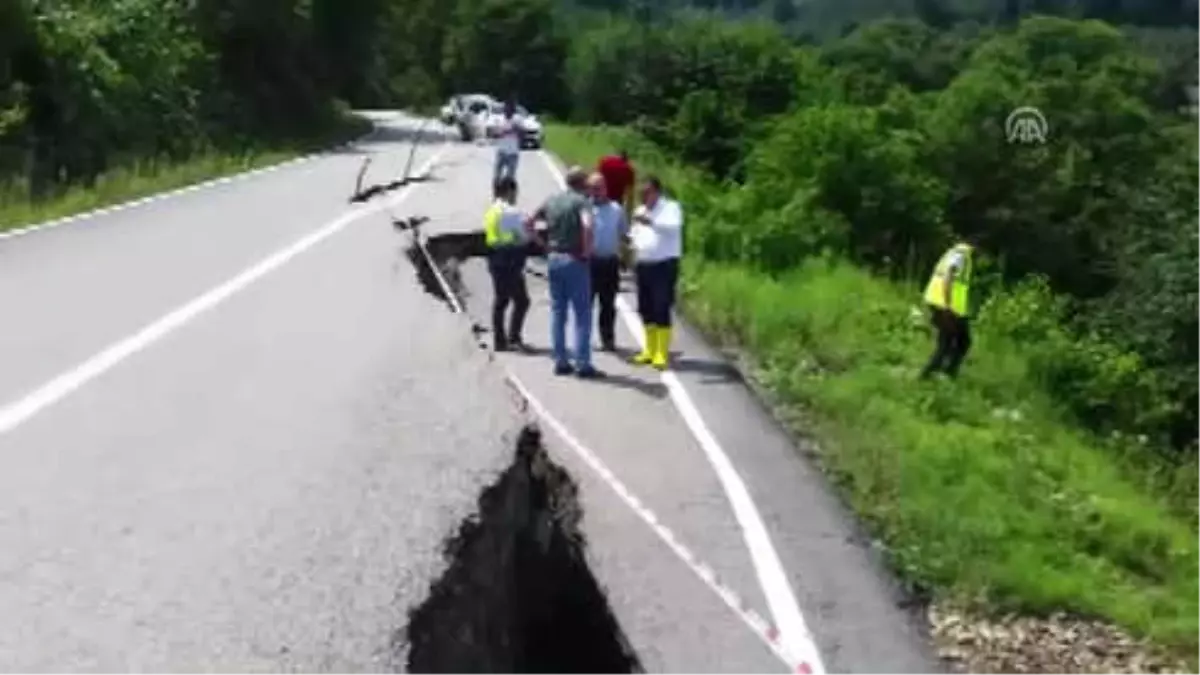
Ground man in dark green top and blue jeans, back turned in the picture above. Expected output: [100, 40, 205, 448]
[526, 167, 602, 378]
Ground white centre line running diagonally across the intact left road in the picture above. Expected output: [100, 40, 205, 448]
[0, 147, 449, 436]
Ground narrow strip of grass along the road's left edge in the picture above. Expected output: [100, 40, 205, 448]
[0, 118, 371, 232]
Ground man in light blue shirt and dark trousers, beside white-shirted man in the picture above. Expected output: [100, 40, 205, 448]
[588, 172, 629, 352]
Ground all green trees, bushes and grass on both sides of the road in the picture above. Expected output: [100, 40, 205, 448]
[0, 0, 1200, 663]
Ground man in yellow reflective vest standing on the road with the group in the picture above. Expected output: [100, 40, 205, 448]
[484, 175, 529, 352]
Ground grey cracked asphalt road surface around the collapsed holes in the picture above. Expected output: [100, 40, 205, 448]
[0, 114, 937, 675]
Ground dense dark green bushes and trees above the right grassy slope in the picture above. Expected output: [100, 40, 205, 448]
[552, 10, 1200, 449]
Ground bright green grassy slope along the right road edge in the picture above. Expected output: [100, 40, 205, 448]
[547, 126, 1200, 662]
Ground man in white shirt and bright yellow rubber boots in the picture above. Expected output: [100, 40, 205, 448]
[630, 175, 683, 370]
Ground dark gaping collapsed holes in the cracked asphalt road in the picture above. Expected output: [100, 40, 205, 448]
[392, 216, 644, 675]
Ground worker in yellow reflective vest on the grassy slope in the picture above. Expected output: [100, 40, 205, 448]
[920, 241, 974, 378]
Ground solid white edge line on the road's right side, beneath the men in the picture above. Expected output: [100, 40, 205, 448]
[538, 150, 824, 675]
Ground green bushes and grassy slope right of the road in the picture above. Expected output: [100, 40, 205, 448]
[537, 2, 1200, 664]
